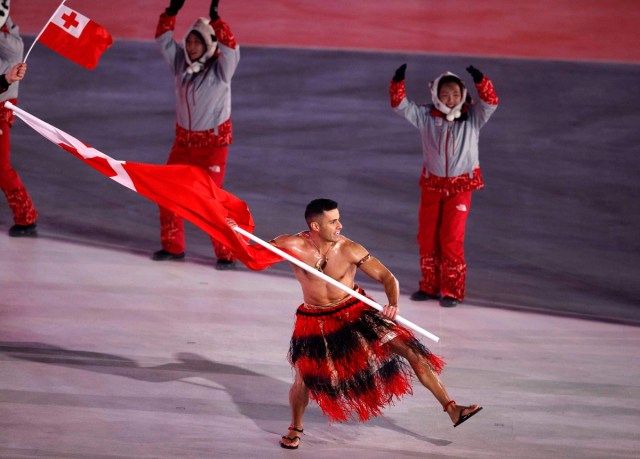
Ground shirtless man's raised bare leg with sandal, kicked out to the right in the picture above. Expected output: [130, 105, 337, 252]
[389, 339, 478, 424]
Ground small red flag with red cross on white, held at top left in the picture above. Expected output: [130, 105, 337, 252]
[37, 4, 113, 70]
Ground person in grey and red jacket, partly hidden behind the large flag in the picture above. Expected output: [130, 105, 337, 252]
[152, 0, 240, 269]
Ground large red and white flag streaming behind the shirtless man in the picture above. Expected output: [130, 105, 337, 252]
[5, 102, 283, 271]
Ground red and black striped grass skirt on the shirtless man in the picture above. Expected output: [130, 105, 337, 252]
[288, 286, 444, 422]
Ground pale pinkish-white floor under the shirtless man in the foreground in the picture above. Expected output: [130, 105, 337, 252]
[0, 235, 640, 459]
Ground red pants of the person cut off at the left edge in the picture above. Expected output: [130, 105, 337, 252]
[0, 106, 38, 225]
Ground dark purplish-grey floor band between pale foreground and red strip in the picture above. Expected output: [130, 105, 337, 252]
[8, 39, 640, 325]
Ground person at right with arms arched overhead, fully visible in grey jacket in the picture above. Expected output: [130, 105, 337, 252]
[389, 64, 498, 307]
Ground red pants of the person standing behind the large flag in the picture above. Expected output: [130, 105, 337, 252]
[160, 142, 235, 261]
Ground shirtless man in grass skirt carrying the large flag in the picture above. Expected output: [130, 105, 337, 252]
[270, 199, 482, 449]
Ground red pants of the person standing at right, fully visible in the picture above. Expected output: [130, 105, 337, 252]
[418, 187, 471, 301]
